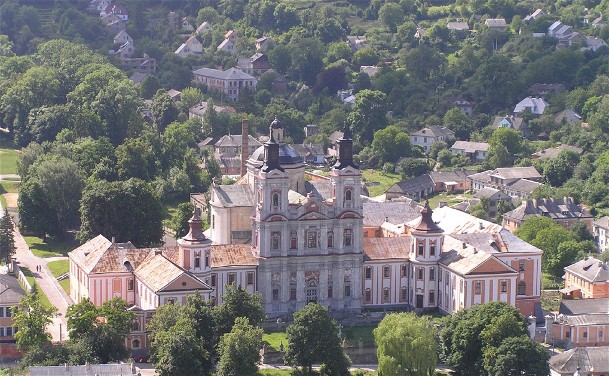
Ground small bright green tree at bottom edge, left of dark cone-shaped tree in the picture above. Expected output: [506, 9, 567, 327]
[216, 317, 263, 376]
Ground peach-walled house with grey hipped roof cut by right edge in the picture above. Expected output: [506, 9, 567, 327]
[560, 256, 609, 298]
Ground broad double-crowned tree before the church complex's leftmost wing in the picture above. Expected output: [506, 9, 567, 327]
[66, 297, 135, 363]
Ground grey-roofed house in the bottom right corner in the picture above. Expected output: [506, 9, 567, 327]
[550, 346, 609, 376]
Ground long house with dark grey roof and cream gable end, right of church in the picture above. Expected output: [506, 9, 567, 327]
[503, 197, 594, 232]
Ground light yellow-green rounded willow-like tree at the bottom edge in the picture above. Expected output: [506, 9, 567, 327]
[374, 313, 437, 376]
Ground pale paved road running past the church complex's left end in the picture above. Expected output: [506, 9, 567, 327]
[0, 201, 74, 342]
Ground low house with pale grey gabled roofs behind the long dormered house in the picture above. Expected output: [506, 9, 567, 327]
[468, 167, 542, 199]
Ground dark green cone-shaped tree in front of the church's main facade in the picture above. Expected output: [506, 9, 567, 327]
[285, 303, 351, 375]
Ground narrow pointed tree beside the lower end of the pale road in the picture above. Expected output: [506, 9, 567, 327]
[12, 283, 57, 351]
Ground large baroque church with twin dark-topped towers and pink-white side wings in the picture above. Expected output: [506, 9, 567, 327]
[69, 120, 542, 332]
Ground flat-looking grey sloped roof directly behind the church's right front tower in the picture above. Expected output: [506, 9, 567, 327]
[362, 202, 422, 226]
